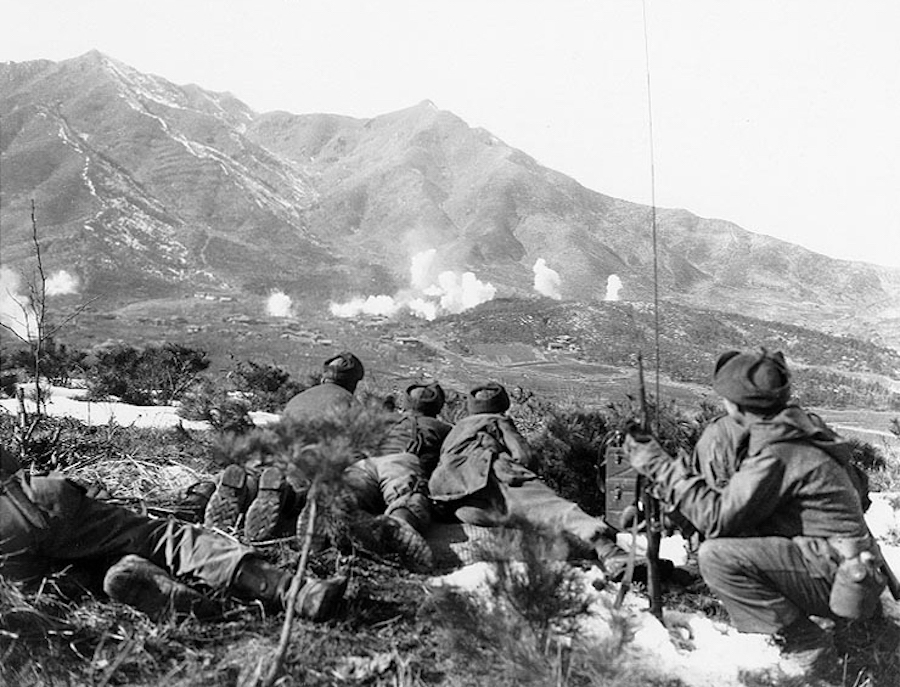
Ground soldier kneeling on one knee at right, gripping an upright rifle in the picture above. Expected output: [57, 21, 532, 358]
[625, 350, 890, 668]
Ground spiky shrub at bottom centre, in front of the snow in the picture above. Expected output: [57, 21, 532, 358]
[427, 523, 682, 687]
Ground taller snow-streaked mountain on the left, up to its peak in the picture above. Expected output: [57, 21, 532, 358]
[0, 53, 328, 300]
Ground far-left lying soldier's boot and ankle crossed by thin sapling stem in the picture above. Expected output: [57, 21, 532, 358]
[230, 556, 347, 621]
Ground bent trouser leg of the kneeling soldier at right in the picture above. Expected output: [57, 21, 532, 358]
[699, 537, 833, 634]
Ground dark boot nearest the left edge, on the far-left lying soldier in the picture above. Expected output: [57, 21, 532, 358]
[103, 555, 224, 622]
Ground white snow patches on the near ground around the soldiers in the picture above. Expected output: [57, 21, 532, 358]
[0, 388, 900, 687]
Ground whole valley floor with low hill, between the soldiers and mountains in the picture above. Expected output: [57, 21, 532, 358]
[0, 297, 900, 414]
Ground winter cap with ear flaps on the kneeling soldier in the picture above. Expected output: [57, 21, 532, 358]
[713, 348, 791, 412]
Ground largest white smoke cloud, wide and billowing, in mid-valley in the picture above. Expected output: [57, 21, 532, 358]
[330, 248, 497, 320]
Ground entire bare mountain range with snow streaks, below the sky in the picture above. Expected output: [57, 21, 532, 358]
[0, 52, 900, 347]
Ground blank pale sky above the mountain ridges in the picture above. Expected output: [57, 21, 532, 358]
[0, 0, 900, 266]
